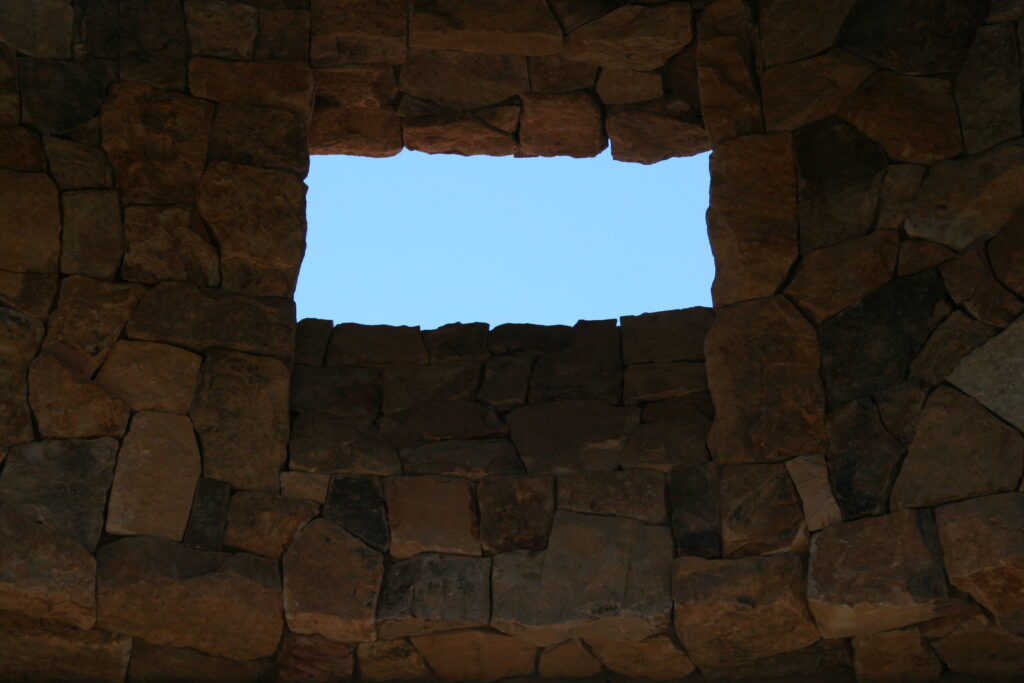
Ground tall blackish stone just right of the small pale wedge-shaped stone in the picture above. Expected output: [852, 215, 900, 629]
[825, 398, 912, 519]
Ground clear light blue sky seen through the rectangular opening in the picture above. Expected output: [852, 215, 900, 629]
[295, 151, 715, 330]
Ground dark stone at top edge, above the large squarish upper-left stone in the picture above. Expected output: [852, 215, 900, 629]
[118, 0, 188, 90]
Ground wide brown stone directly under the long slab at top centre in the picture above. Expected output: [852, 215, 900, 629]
[398, 49, 529, 110]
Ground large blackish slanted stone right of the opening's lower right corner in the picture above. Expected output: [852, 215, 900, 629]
[819, 269, 949, 407]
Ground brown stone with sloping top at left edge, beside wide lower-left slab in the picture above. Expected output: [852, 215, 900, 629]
[0, 509, 96, 630]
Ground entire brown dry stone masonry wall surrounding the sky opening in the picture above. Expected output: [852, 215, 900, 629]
[0, 0, 1024, 683]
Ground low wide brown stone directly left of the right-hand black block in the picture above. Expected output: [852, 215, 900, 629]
[558, 470, 665, 524]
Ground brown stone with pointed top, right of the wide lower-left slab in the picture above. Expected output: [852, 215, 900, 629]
[282, 519, 384, 642]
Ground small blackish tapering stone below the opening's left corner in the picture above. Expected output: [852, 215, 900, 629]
[324, 476, 390, 553]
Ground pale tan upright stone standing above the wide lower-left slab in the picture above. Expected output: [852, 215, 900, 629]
[106, 412, 202, 541]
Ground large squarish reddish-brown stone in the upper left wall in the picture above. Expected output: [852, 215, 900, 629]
[100, 83, 213, 204]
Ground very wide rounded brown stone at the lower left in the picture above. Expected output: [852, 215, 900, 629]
[96, 537, 283, 661]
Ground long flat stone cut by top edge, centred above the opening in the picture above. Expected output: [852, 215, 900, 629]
[409, 0, 562, 55]
